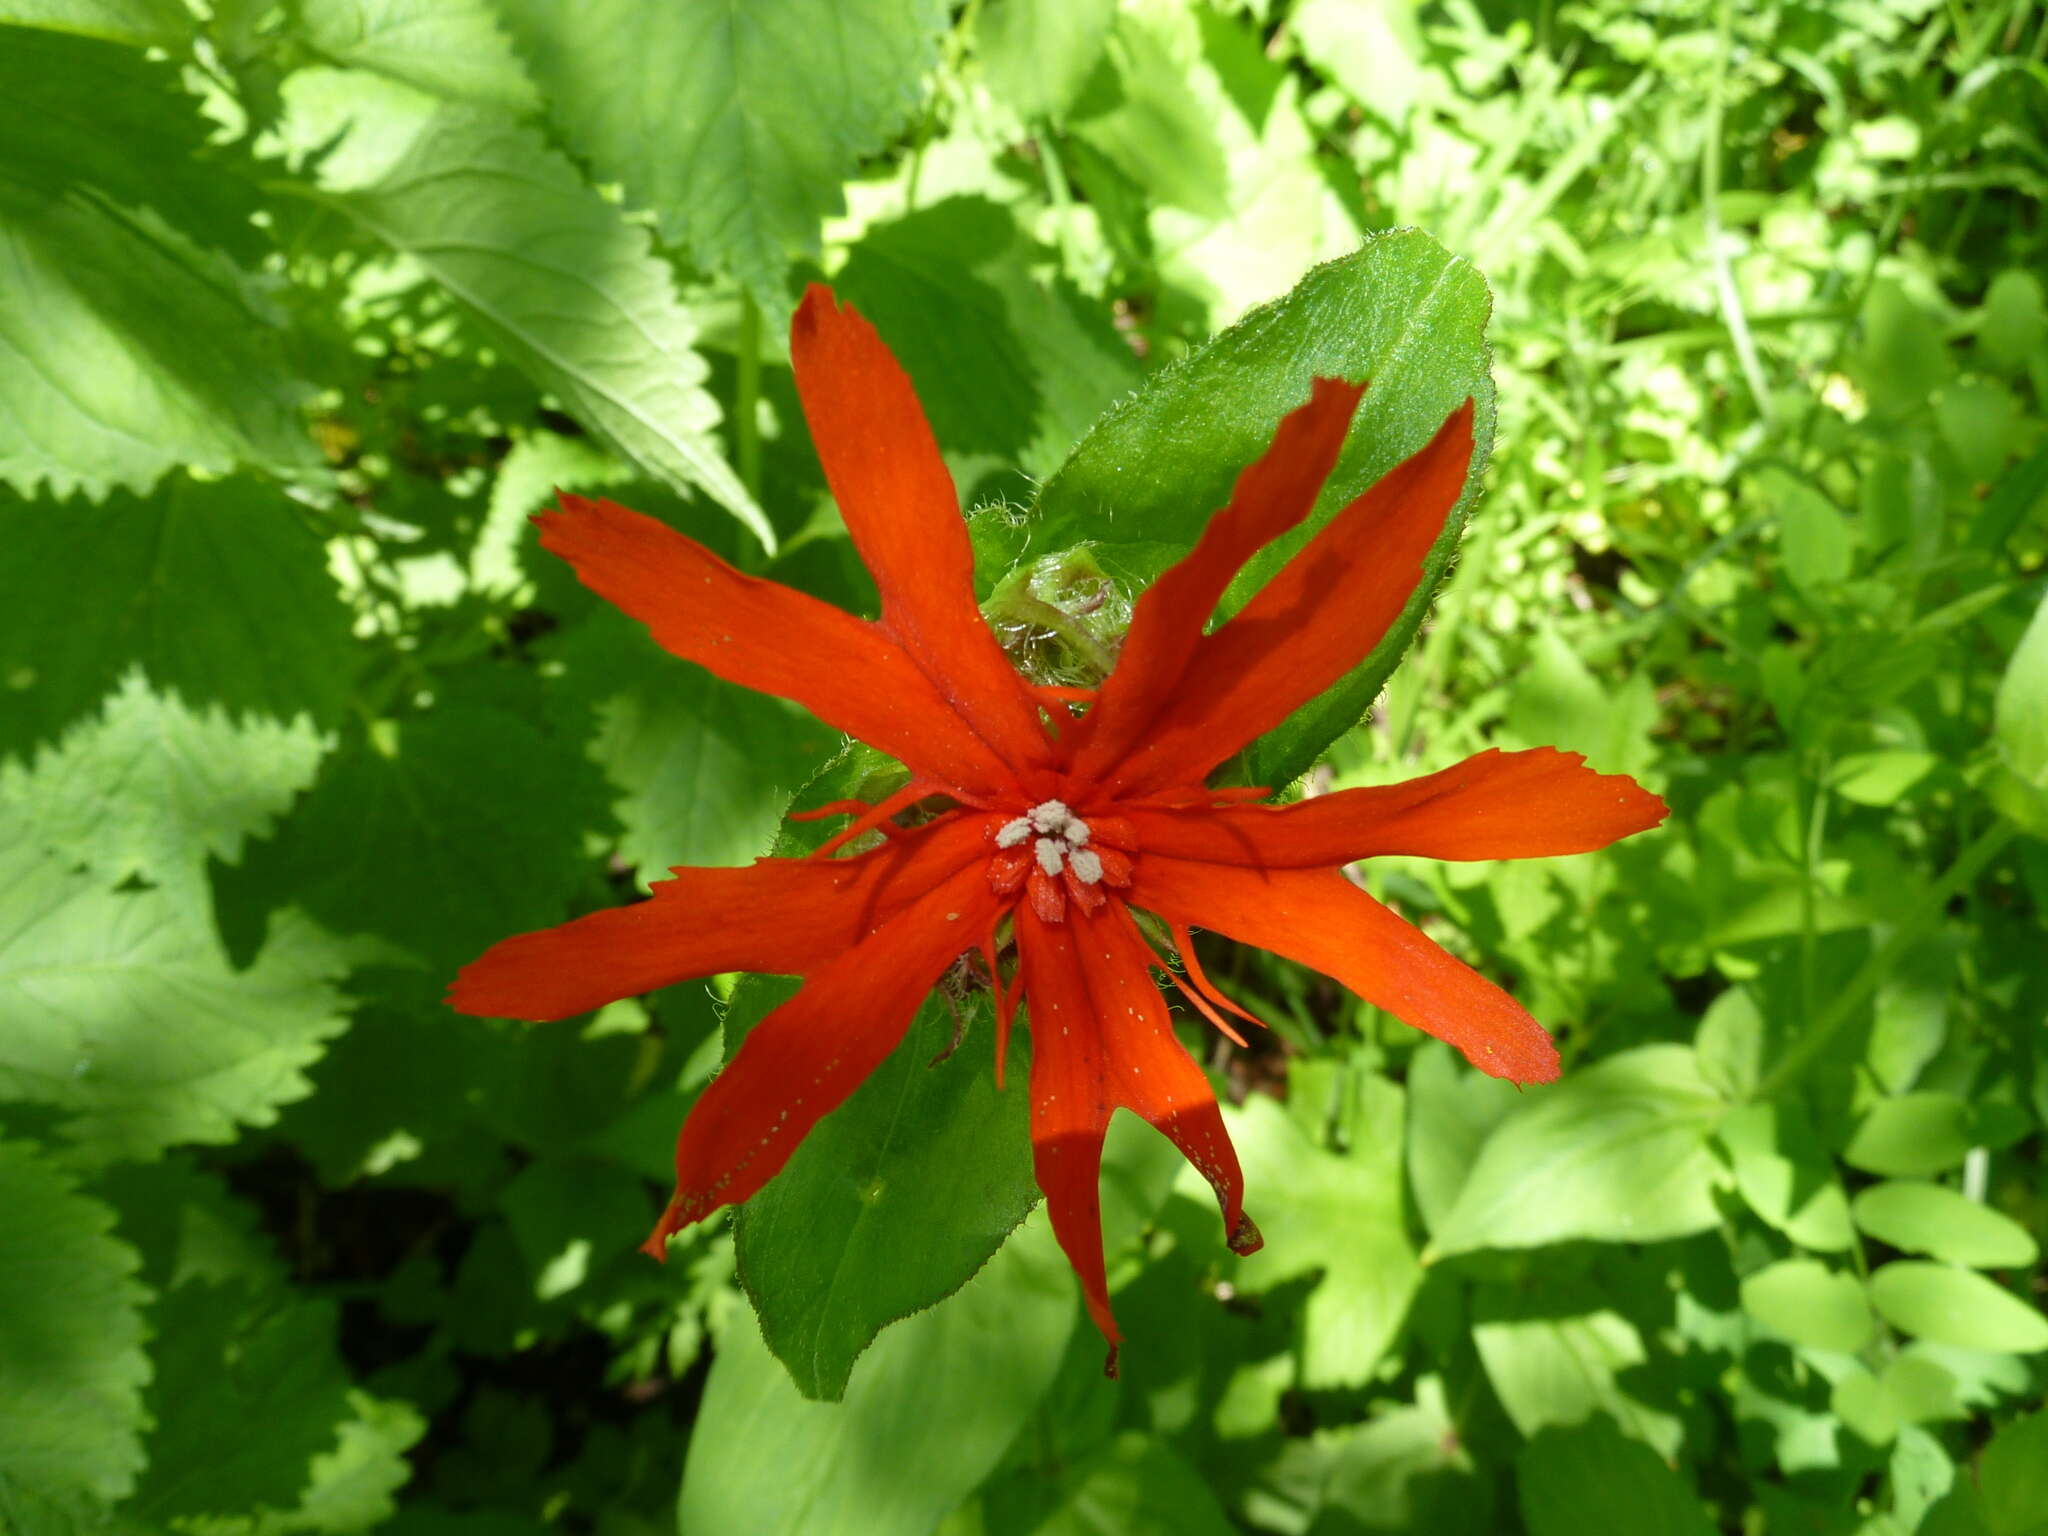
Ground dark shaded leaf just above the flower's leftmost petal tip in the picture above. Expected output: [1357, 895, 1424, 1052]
[223, 698, 606, 977]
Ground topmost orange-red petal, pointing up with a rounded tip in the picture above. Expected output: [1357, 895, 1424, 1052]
[788, 283, 1051, 768]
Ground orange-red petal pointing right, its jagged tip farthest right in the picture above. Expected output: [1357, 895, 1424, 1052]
[1126, 748, 1669, 868]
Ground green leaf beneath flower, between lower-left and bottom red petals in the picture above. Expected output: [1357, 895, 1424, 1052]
[725, 977, 1038, 1401]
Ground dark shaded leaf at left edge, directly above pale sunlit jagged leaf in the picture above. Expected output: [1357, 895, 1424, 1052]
[0, 477, 360, 752]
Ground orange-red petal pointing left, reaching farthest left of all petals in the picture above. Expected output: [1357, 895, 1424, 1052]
[449, 817, 987, 1020]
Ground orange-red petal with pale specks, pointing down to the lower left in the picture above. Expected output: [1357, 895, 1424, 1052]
[645, 866, 997, 1257]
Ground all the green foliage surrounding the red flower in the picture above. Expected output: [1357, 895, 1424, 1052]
[0, 0, 2048, 1536]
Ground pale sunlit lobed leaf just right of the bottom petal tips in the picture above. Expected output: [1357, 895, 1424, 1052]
[1229, 1075, 1421, 1389]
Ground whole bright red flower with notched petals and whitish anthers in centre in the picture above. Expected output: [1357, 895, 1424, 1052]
[449, 287, 1665, 1368]
